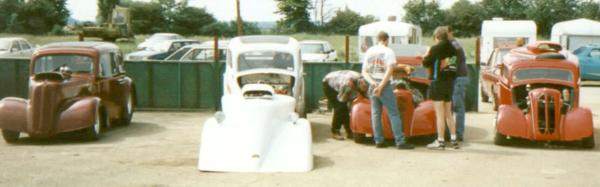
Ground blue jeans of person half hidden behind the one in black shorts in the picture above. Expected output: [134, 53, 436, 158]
[452, 76, 469, 139]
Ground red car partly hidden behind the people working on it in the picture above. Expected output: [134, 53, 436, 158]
[350, 46, 437, 143]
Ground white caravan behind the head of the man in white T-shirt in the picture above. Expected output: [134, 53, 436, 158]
[357, 21, 422, 62]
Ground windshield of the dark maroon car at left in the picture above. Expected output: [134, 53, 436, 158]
[34, 55, 93, 73]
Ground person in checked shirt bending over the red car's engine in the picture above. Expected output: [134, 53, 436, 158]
[323, 70, 360, 140]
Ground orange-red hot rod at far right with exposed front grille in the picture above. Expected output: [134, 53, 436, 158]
[494, 42, 594, 148]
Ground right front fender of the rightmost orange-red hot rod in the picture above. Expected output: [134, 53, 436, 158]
[561, 107, 594, 141]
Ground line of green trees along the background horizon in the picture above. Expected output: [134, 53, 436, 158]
[0, 0, 600, 37]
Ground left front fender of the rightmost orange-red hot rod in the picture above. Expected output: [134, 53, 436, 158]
[496, 105, 530, 138]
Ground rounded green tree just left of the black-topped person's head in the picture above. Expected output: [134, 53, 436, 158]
[404, 0, 446, 34]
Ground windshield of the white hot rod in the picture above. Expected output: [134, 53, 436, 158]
[238, 51, 294, 71]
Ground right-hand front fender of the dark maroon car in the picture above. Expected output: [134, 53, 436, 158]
[57, 97, 100, 132]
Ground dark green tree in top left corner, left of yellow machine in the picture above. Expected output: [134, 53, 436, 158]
[9, 0, 69, 34]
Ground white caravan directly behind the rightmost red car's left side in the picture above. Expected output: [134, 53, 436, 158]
[479, 18, 537, 64]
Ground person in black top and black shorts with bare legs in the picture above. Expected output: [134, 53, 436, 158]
[423, 27, 459, 149]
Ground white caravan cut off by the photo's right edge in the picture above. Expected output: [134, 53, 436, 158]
[551, 18, 600, 51]
